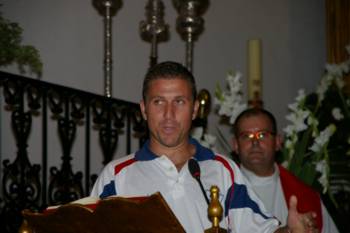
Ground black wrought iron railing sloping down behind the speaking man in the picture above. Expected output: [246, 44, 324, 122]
[0, 72, 146, 233]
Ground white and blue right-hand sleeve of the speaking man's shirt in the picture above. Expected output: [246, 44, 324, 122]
[226, 161, 280, 233]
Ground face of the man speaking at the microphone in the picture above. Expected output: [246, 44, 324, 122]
[140, 78, 198, 147]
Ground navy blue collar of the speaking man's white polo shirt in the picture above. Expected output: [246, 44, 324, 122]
[135, 137, 215, 161]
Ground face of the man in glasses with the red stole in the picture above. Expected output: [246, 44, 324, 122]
[233, 114, 281, 176]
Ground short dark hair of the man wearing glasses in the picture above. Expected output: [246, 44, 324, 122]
[233, 108, 277, 137]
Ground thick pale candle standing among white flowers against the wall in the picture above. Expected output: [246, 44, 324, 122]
[248, 39, 262, 100]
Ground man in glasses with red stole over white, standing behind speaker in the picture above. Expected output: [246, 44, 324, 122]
[233, 108, 338, 233]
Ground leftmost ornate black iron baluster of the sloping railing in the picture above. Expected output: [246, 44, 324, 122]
[0, 79, 41, 232]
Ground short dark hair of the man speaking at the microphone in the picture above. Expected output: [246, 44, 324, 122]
[142, 61, 197, 101]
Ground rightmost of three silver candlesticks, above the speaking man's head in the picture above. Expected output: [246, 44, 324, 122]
[173, 0, 209, 71]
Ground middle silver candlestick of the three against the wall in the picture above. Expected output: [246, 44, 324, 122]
[140, 0, 168, 67]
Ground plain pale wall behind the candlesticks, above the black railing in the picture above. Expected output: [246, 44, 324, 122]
[1, 0, 326, 158]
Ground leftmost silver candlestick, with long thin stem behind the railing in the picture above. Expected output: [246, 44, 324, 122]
[92, 0, 122, 97]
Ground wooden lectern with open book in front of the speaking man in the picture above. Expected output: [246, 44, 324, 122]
[19, 193, 185, 233]
